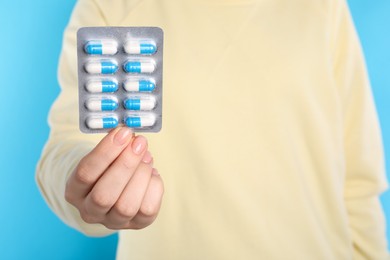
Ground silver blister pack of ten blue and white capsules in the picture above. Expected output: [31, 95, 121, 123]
[77, 27, 163, 133]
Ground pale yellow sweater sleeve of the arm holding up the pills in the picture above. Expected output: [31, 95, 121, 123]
[36, 0, 113, 236]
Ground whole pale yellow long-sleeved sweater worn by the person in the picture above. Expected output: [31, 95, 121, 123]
[37, 0, 389, 260]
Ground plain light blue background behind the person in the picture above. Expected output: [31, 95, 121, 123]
[0, 0, 390, 259]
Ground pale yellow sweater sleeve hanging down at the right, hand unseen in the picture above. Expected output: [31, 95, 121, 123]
[331, 1, 390, 259]
